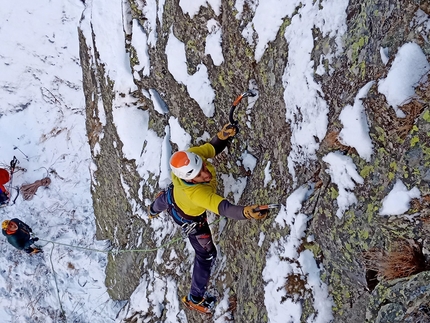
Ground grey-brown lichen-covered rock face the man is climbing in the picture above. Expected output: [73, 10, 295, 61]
[81, 0, 430, 323]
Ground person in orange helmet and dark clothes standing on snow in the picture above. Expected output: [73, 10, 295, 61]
[1, 219, 43, 254]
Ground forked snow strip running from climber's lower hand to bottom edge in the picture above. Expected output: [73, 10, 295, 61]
[263, 186, 333, 323]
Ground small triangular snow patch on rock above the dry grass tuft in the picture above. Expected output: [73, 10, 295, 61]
[379, 179, 421, 215]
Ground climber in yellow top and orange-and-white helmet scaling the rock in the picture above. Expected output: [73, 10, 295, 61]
[148, 124, 268, 314]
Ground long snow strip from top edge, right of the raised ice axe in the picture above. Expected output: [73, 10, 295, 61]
[284, 0, 348, 182]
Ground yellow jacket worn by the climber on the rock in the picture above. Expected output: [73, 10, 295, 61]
[172, 143, 224, 216]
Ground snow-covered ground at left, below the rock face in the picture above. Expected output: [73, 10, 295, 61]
[0, 0, 121, 323]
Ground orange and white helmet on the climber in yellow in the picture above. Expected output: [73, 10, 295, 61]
[170, 151, 203, 180]
